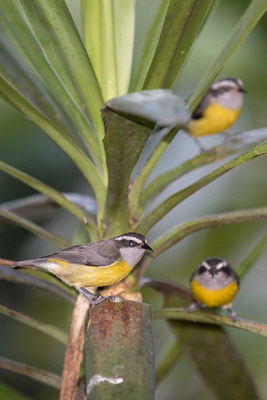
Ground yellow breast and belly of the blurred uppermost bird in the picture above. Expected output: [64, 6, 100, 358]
[187, 104, 241, 137]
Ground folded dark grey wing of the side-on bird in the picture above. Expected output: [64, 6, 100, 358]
[42, 240, 120, 267]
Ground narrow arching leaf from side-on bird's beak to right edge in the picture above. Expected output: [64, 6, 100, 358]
[135, 207, 267, 282]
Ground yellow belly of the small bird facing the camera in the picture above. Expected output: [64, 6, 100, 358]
[190, 279, 238, 307]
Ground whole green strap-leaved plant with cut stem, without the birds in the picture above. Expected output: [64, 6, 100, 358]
[0, 0, 267, 400]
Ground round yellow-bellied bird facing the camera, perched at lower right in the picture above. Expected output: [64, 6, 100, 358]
[188, 257, 239, 319]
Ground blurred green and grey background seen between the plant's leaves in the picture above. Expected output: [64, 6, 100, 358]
[0, 0, 267, 400]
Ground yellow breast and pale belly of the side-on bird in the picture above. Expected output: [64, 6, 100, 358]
[46, 258, 131, 287]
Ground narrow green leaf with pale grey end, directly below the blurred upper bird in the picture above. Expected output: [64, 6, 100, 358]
[140, 128, 267, 209]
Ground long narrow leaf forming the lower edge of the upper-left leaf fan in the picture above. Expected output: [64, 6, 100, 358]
[0, 79, 106, 212]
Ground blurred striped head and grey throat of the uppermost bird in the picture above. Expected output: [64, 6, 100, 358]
[210, 78, 246, 109]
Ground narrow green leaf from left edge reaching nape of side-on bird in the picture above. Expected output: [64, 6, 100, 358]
[0, 161, 98, 240]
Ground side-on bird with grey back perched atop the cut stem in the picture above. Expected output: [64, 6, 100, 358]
[13, 232, 153, 305]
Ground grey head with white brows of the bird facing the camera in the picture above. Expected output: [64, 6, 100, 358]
[190, 257, 239, 289]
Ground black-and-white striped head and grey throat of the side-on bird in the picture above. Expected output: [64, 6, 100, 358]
[114, 232, 153, 267]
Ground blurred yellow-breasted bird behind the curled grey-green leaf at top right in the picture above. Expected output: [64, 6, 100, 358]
[187, 78, 246, 138]
